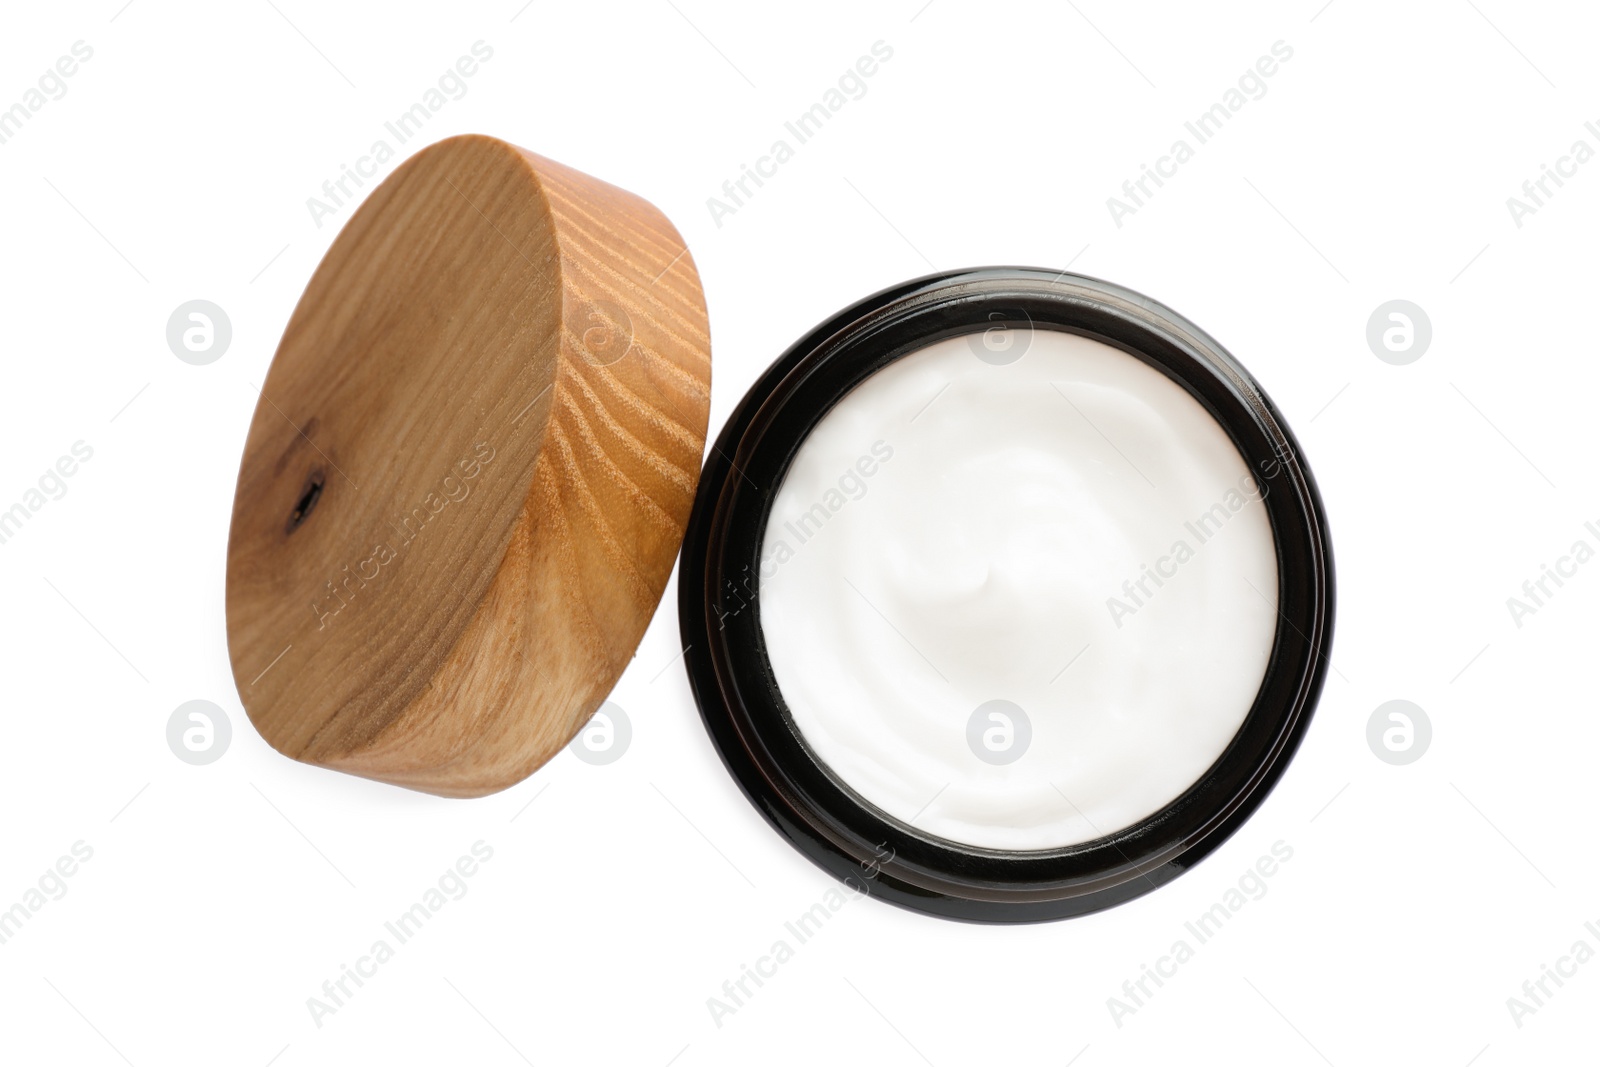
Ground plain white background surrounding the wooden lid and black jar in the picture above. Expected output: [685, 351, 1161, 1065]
[0, 0, 1600, 1067]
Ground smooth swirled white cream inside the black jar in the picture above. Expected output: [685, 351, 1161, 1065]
[760, 330, 1277, 849]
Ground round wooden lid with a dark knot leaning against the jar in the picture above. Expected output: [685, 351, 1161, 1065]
[227, 136, 710, 797]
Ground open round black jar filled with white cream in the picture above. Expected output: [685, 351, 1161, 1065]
[678, 269, 1333, 921]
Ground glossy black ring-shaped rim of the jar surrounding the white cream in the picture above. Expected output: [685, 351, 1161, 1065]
[678, 267, 1334, 923]
